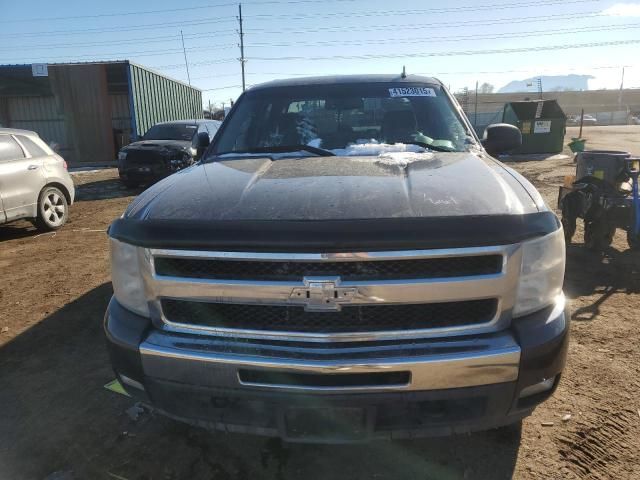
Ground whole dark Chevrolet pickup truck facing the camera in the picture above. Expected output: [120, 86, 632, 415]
[105, 75, 569, 442]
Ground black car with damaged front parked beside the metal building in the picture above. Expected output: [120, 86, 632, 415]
[118, 120, 221, 188]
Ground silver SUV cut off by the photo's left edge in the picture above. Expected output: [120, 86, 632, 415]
[0, 128, 75, 231]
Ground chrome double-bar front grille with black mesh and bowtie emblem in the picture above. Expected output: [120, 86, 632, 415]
[141, 245, 521, 342]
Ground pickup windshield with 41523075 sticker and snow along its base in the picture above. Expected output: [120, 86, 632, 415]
[212, 83, 472, 155]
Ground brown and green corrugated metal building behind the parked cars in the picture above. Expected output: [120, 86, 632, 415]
[0, 60, 202, 164]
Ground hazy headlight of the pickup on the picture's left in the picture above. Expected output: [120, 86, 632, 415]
[109, 238, 149, 317]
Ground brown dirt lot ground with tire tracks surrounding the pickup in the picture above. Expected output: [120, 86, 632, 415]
[0, 126, 640, 480]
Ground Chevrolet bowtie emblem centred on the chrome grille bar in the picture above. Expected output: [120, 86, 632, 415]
[289, 277, 357, 311]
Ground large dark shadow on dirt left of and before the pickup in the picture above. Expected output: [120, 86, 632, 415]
[0, 283, 520, 480]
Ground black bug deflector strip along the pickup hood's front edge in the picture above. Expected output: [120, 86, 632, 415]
[109, 211, 560, 253]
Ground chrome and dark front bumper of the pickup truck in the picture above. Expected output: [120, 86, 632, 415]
[105, 299, 569, 442]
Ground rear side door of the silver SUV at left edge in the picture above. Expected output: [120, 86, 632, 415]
[0, 134, 45, 221]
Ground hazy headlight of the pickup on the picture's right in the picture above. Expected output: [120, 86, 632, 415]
[513, 228, 566, 317]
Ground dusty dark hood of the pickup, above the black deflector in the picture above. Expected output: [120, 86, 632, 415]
[126, 152, 546, 222]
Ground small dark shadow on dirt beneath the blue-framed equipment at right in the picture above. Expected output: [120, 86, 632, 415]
[565, 244, 640, 321]
